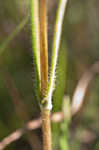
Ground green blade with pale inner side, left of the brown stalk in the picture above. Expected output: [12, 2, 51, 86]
[30, 0, 41, 101]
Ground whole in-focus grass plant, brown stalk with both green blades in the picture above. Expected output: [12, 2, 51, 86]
[30, 0, 67, 150]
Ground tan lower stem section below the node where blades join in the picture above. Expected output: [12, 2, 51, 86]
[42, 109, 52, 150]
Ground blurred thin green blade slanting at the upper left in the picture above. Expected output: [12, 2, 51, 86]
[0, 17, 28, 55]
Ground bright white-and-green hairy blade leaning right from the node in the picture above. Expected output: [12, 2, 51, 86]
[46, 0, 67, 109]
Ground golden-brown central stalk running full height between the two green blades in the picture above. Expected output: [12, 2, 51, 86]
[39, 0, 52, 150]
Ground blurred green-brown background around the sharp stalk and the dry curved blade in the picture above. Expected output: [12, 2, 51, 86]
[0, 0, 99, 150]
